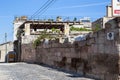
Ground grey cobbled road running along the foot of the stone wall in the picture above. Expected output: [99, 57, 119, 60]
[0, 63, 93, 80]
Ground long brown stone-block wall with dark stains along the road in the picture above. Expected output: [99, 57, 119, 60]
[21, 17, 120, 80]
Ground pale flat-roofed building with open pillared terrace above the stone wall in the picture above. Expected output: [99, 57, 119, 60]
[13, 16, 91, 43]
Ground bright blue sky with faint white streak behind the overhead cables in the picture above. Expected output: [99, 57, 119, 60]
[0, 0, 111, 43]
